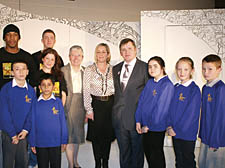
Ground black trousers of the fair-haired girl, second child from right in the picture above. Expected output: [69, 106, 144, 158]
[172, 137, 196, 168]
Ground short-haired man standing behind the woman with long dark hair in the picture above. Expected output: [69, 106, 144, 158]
[32, 29, 64, 70]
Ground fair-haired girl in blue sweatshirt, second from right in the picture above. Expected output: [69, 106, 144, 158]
[167, 57, 201, 168]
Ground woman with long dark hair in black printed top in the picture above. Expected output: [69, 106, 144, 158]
[36, 48, 67, 106]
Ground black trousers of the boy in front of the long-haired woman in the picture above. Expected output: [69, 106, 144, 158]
[36, 146, 61, 168]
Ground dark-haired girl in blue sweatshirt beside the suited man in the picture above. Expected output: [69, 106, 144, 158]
[135, 56, 174, 168]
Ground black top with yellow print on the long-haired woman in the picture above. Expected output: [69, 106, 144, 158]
[35, 70, 67, 98]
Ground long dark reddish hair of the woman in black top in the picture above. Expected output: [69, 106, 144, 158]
[41, 48, 63, 81]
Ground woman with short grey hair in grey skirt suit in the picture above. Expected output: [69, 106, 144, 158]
[61, 45, 85, 168]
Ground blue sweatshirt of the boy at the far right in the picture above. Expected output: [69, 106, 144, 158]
[199, 80, 225, 148]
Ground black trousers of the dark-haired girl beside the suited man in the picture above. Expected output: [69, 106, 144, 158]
[143, 131, 166, 168]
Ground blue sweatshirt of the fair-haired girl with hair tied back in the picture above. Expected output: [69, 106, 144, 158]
[168, 81, 201, 141]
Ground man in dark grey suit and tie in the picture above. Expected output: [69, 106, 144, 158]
[112, 38, 149, 168]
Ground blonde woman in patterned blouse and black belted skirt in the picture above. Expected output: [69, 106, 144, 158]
[83, 43, 115, 168]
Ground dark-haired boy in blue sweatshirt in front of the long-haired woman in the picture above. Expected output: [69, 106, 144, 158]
[29, 74, 68, 168]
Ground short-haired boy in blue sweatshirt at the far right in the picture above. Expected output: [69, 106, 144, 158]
[199, 55, 225, 168]
